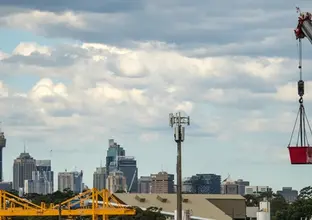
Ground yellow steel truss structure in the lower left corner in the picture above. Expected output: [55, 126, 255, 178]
[0, 188, 135, 220]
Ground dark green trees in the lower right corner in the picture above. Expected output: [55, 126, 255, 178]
[245, 186, 312, 220]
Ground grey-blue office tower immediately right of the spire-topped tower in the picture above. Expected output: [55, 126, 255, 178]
[31, 160, 54, 195]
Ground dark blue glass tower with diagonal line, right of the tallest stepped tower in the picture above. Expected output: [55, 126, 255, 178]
[117, 156, 138, 193]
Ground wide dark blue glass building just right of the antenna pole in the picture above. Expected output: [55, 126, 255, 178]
[182, 174, 221, 194]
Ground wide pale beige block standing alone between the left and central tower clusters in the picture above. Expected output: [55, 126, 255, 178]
[58, 170, 83, 193]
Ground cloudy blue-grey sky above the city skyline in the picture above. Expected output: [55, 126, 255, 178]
[0, 0, 312, 190]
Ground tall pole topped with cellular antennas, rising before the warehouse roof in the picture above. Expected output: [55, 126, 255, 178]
[169, 112, 190, 220]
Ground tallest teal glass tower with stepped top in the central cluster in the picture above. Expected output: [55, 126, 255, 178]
[106, 139, 126, 175]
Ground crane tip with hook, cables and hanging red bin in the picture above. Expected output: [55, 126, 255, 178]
[288, 8, 312, 165]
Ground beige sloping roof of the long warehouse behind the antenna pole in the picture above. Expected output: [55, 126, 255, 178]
[114, 193, 245, 220]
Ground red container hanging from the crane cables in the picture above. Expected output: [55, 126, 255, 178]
[288, 146, 312, 164]
